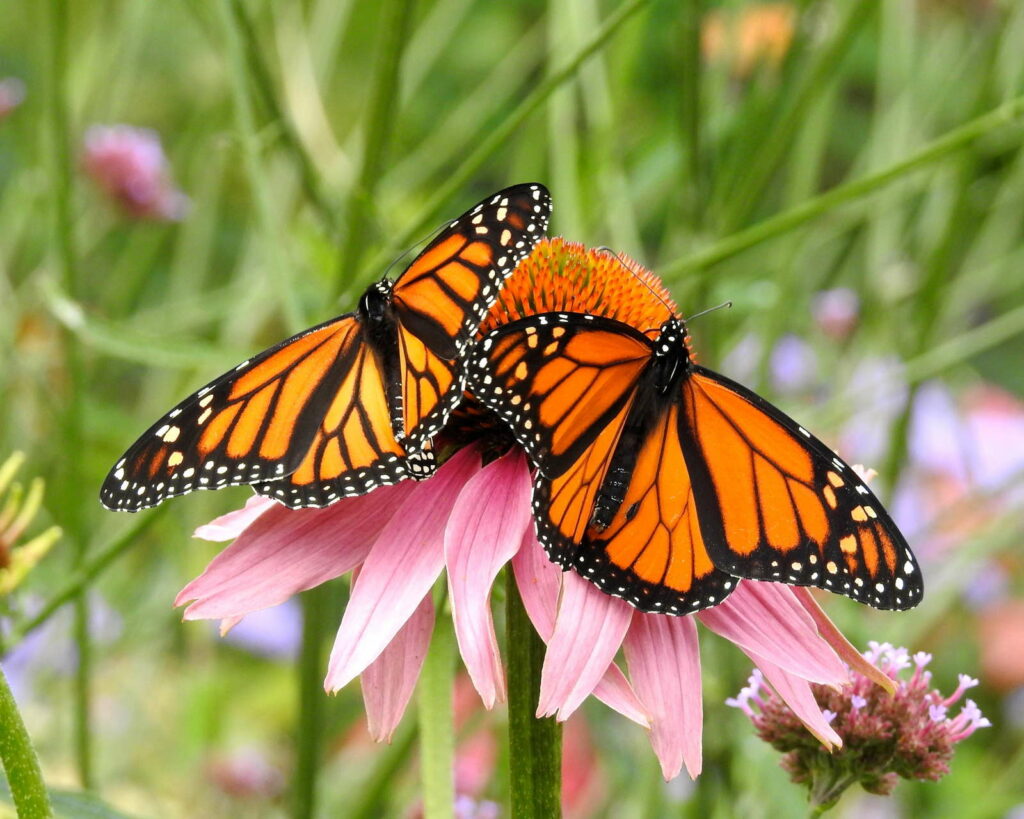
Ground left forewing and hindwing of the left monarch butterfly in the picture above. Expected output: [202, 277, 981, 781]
[100, 314, 432, 512]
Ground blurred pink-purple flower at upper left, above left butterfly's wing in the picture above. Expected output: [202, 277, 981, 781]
[82, 125, 188, 221]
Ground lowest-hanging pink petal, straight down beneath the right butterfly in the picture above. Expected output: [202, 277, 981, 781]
[624, 612, 703, 780]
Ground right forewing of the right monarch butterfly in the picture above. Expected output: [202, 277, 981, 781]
[681, 367, 924, 609]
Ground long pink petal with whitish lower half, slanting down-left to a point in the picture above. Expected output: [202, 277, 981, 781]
[324, 446, 480, 691]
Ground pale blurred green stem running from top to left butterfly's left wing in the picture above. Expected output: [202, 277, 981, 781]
[217, 0, 303, 332]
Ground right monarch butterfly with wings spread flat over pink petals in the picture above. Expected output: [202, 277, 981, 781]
[467, 312, 923, 614]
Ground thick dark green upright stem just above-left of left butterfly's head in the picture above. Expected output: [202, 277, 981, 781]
[334, 0, 416, 297]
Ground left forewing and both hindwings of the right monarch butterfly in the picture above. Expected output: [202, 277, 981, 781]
[468, 313, 735, 614]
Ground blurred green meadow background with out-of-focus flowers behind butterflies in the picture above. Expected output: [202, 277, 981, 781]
[0, 0, 1024, 817]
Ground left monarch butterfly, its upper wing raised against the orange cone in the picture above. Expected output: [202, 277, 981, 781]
[99, 183, 551, 512]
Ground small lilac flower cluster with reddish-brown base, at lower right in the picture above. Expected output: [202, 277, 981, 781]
[727, 642, 990, 806]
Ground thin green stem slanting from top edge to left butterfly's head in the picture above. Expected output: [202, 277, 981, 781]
[367, 0, 650, 284]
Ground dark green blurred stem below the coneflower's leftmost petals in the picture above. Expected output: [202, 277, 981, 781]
[292, 585, 334, 819]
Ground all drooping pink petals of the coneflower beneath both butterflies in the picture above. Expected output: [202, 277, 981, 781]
[176, 446, 880, 779]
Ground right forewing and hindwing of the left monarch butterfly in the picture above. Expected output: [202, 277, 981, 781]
[391, 183, 551, 446]
